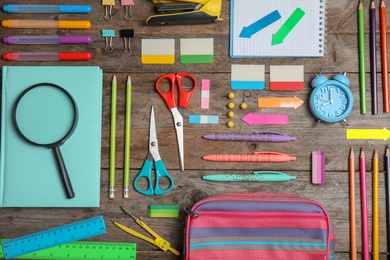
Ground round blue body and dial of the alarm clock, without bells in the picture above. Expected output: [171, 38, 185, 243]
[310, 84, 353, 123]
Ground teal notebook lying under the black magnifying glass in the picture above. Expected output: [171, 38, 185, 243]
[0, 66, 103, 207]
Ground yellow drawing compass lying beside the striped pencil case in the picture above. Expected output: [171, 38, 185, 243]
[114, 207, 180, 256]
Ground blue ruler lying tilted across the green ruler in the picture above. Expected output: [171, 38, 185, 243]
[1, 216, 106, 259]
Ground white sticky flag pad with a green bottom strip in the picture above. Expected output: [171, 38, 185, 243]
[180, 38, 214, 64]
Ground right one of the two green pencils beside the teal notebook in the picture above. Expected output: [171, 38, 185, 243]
[123, 76, 132, 198]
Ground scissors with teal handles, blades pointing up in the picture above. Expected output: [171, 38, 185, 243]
[134, 106, 174, 196]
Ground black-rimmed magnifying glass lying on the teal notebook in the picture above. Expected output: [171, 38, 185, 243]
[12, 83, 78, 199]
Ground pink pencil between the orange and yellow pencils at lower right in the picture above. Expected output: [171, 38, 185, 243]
[359, 147, 370, 260]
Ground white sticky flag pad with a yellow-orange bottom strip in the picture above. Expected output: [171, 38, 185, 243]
[141, 39, 175, 64]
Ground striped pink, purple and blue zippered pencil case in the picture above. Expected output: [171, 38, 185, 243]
[185, 193, 336, 260]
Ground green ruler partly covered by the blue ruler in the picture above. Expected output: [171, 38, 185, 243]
[0, 239, 136, 260]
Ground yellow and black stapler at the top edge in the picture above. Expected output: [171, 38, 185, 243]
[146, 0, 222, 25]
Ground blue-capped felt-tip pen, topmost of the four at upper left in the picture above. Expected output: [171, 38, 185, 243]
[2, 4, 92, 14]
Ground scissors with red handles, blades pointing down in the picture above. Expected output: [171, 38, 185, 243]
[156, 72, 196, 171]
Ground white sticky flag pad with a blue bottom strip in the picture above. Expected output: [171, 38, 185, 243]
[230, 64, 265, 90]
